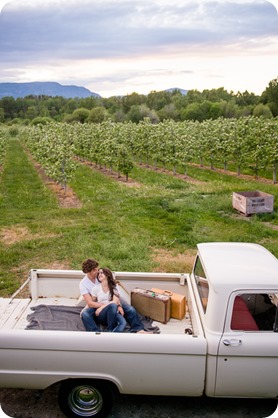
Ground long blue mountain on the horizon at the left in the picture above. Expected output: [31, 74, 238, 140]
[0, 81, 100, 99]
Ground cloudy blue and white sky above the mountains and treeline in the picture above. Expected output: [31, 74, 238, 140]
[0, 0, 278, 97]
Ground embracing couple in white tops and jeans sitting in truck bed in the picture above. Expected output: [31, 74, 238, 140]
[79, 259, 148, 333]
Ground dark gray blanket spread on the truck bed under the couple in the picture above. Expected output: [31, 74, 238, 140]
[26, 305, 160, 334]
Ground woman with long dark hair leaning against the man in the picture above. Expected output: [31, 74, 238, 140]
[91, 268, 126, 332]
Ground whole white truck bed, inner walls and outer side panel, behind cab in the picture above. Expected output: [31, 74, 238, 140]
[0, 270, 207, 396]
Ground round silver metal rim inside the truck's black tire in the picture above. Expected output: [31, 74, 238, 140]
[69, 385, 103, 417]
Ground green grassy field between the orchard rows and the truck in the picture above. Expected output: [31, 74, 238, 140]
[0, 139, 278, 296]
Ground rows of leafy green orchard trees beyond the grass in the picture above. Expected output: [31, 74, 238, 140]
[20, 117, 278, 185]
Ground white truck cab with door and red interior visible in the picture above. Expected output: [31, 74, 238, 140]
[192, 243, 278, 398]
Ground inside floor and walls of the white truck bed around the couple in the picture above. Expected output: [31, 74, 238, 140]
[0, 270, 195, 334]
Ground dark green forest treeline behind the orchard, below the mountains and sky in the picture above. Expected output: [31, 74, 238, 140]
[0, 78, 278, 125]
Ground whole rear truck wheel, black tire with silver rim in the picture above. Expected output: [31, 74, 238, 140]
[58, 379, 114, 418]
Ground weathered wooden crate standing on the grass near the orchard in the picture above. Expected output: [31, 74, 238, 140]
[233, 190, 274, 216]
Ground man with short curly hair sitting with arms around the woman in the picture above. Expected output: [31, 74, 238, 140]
[79, 258, 144, 332]
